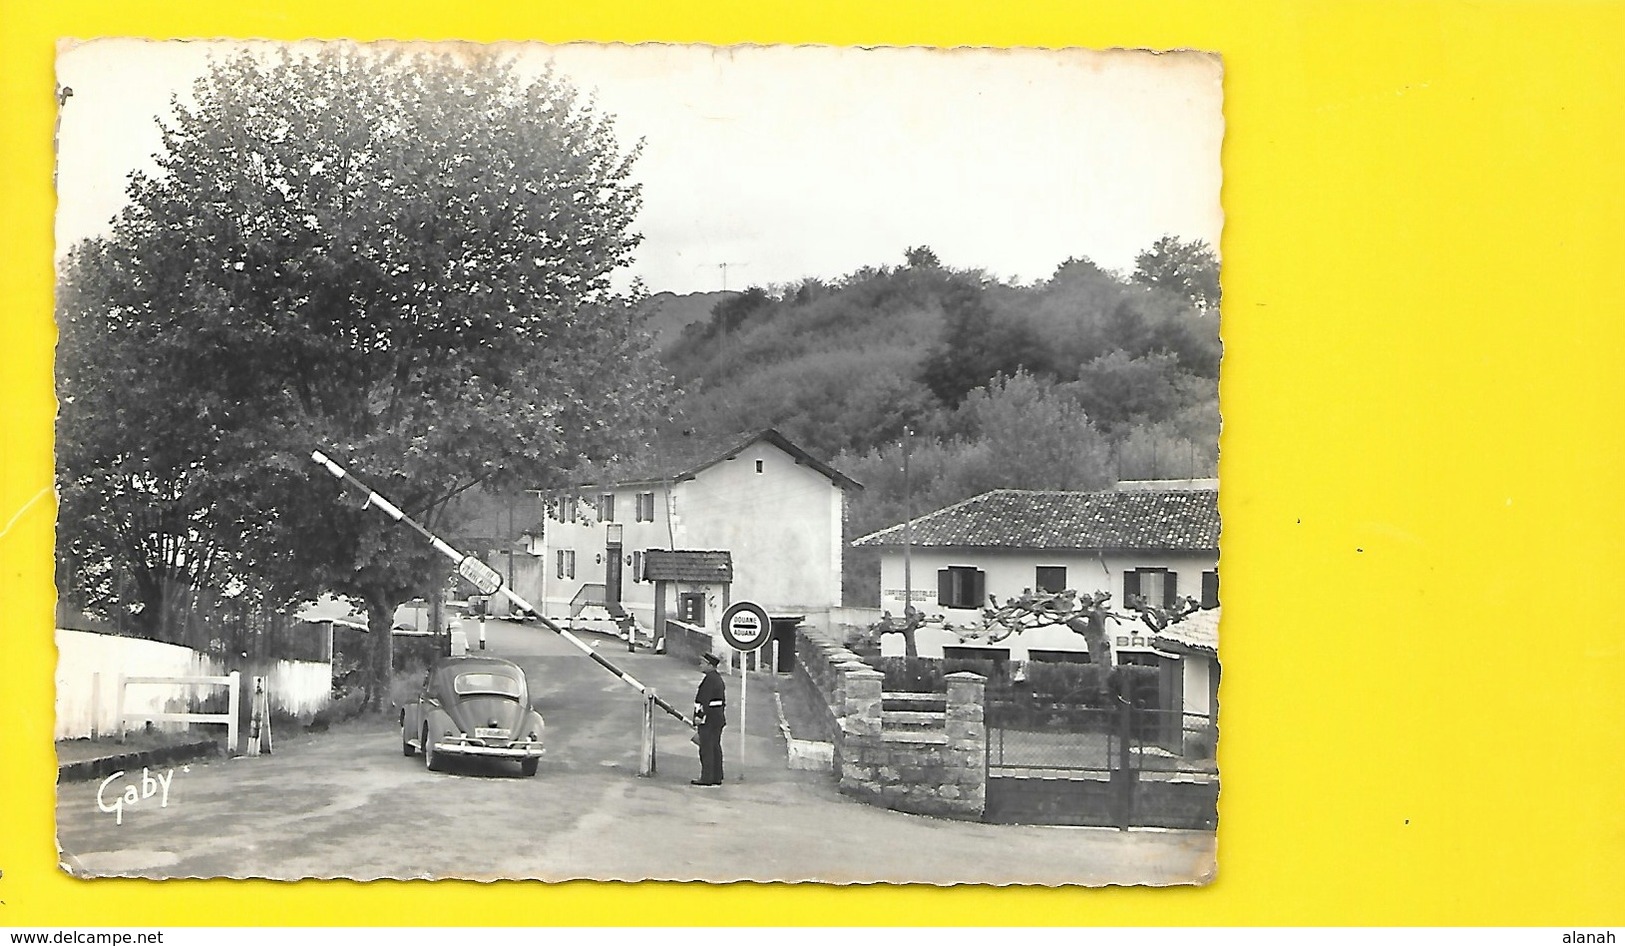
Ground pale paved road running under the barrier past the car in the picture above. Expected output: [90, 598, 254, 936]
[57, 623, 1214, 884]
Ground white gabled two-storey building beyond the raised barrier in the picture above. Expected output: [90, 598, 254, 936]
[515, 429, 861, 640]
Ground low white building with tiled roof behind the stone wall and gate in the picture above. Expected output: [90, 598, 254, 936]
[852, 484, 1219, 660]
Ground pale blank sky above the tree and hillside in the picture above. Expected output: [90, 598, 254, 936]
[57, 41, 1224, 293]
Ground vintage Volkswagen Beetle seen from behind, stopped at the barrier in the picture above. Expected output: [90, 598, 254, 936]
[401, 655, 543, 775]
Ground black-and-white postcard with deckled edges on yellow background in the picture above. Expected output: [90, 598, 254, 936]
[55, 39, 1224, 886]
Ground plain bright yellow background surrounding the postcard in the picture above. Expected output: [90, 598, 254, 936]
[0, 0, 1625, 926]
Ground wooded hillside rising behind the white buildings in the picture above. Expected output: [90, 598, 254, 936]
[633, 237, 1220, 605]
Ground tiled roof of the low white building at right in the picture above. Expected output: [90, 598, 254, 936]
[852, 489, 1219, 551]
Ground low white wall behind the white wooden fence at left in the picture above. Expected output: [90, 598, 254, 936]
[55, 627, 333, 740]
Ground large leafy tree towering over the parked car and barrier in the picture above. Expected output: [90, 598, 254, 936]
[62, 44, 660, 699]
